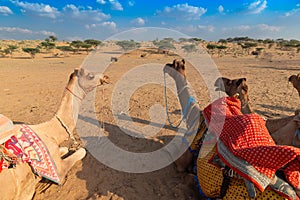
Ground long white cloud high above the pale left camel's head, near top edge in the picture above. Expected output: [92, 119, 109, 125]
[63, 4, 110, 21]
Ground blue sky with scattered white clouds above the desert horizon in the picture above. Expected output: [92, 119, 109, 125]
[0, 0, 300, 41]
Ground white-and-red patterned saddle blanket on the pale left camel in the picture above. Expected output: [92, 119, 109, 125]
[0, 120, 61, 184]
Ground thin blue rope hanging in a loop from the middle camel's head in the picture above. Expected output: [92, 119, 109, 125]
[164, 72, 196, 128]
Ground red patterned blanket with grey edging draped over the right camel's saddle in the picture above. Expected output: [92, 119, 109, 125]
[203, 97, 300, 194]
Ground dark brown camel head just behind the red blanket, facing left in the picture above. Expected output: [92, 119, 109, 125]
[215, 77, 252, 114]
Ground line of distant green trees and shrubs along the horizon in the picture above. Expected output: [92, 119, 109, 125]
[0, 36, 300, 58]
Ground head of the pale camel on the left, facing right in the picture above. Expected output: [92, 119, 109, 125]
[71, 68, 109, 93]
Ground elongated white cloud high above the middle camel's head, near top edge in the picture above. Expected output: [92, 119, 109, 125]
[157, 3, 207, 20]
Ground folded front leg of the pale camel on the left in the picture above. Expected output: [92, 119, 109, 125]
[61, 148, 86, 178]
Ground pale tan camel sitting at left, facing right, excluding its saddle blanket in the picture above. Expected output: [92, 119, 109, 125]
[0, 68, 109, 200]
